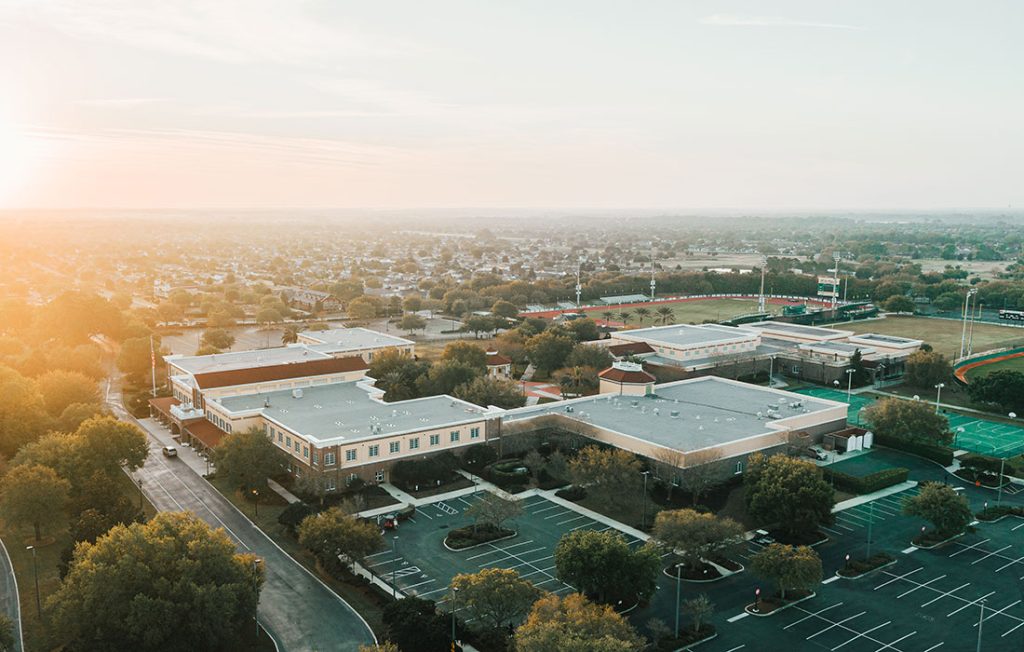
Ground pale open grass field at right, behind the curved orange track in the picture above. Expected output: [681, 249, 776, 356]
[835, 315, 1024, 359]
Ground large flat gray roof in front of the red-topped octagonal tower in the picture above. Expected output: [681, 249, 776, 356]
[505, 377, 844, 451]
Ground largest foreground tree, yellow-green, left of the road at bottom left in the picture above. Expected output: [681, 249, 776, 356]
[47, 512, 263, 652]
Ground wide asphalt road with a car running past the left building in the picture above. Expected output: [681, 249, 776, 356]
[108, 380, 376, 652]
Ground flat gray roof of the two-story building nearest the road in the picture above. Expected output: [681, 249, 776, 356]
[216, 381, 486, 444]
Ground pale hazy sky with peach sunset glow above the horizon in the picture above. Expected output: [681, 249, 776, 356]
[0, 0, 1024, 209]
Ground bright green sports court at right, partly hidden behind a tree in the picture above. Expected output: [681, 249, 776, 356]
[795, 387, 1024, 458]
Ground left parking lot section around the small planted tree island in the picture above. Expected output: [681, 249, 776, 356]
[366, 492, 642, 604]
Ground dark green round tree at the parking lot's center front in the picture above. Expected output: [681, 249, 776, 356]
[555, 530, 662, 604]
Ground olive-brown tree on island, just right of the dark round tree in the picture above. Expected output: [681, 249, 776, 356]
[653, 510, 743, 569]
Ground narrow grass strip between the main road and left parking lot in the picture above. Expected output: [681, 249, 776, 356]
[210, 477, 384, 636]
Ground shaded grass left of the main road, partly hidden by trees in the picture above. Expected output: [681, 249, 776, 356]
[0, 474, 157, 651]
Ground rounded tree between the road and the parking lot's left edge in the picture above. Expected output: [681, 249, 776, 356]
[297, 507, 384, 565]
